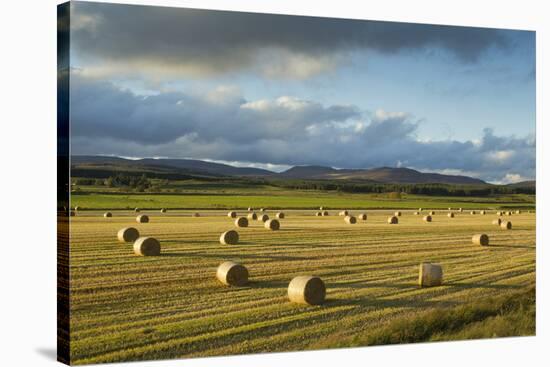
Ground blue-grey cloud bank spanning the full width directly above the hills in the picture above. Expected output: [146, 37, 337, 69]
[71, 73, 535, 181]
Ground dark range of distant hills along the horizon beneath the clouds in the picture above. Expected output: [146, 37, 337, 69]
[71, 156, 486, 185]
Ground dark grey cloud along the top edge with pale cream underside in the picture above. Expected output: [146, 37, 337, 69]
[71, 2, 527, 77]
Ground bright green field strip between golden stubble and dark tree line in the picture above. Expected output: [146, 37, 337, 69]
[71, 189, 535, 210]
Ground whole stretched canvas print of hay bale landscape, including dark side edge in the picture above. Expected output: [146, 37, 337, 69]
[57, 2, 536, 364]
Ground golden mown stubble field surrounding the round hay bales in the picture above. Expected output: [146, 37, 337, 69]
[70, 208, 535, 364]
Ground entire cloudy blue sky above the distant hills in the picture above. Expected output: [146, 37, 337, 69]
[70, 2, 535, 183]
